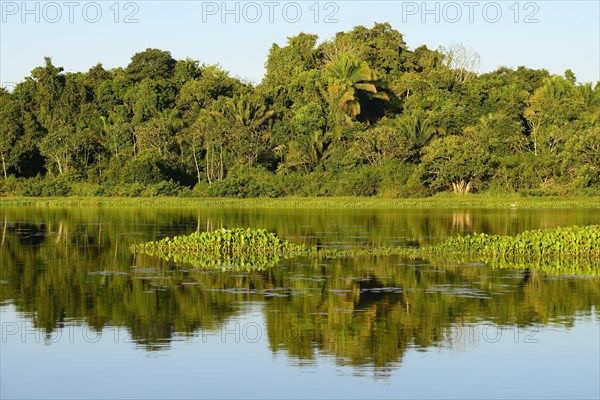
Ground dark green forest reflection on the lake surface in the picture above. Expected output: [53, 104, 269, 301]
[0, 207, 600, 375]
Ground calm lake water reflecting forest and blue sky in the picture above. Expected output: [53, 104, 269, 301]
[0, 207, 600, 399]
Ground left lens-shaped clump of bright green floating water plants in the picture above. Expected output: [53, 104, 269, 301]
[131, 228, 306, 269]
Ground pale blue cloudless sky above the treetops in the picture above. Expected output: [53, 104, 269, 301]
[0, 0, 600, 90]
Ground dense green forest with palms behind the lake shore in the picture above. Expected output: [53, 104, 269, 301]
[0, 23, 600, 197]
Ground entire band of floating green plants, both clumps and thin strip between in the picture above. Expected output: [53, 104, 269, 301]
[132, 225, 600, 276]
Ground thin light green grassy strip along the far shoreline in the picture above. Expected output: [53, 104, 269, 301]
[0, 194, 600, 210]
